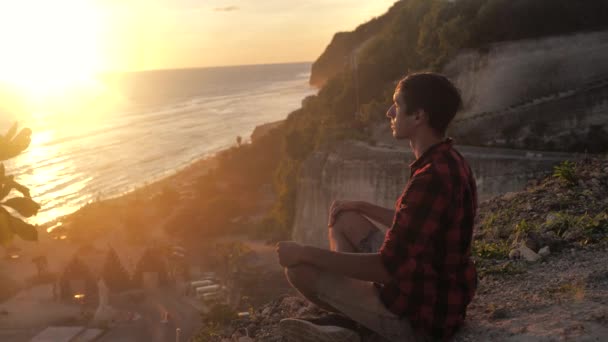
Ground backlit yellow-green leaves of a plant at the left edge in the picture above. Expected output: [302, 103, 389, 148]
[0, 123, 40, 246]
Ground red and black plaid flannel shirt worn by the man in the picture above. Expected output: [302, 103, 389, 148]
[380, 138, 477, 340]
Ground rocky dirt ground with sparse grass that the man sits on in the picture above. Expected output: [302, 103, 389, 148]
[199, 157, 608, 341]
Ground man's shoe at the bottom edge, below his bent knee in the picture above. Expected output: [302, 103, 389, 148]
[279, 317, 361, 342]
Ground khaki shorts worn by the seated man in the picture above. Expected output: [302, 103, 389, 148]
[315, 231, 426, 342]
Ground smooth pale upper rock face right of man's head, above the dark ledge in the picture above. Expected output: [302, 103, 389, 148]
[444, 31, 608, 117]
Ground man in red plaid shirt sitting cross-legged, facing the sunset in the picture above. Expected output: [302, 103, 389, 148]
[277, 73, 477, 341]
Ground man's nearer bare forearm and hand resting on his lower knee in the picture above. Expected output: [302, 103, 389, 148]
[301, 246, 391, 284]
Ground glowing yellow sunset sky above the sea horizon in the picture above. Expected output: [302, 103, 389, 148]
[0, 0, 395, 74]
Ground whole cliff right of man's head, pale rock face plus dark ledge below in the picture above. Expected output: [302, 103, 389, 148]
[444, 31, 608, 153]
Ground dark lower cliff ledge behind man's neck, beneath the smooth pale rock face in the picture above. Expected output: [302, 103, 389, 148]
[449, 79, 608, 153]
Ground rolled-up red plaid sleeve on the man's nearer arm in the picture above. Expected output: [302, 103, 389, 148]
[380, 165, 448, 279]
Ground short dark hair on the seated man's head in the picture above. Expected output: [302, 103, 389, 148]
[397, 72, 462, 136]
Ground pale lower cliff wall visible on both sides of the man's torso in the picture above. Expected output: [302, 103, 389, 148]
[293, 142, 578, 248]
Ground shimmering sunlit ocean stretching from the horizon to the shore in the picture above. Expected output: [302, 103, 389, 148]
[0, 63, 316, 224]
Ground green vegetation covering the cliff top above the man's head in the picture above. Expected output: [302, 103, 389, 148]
[310, 0, 608, 85]
